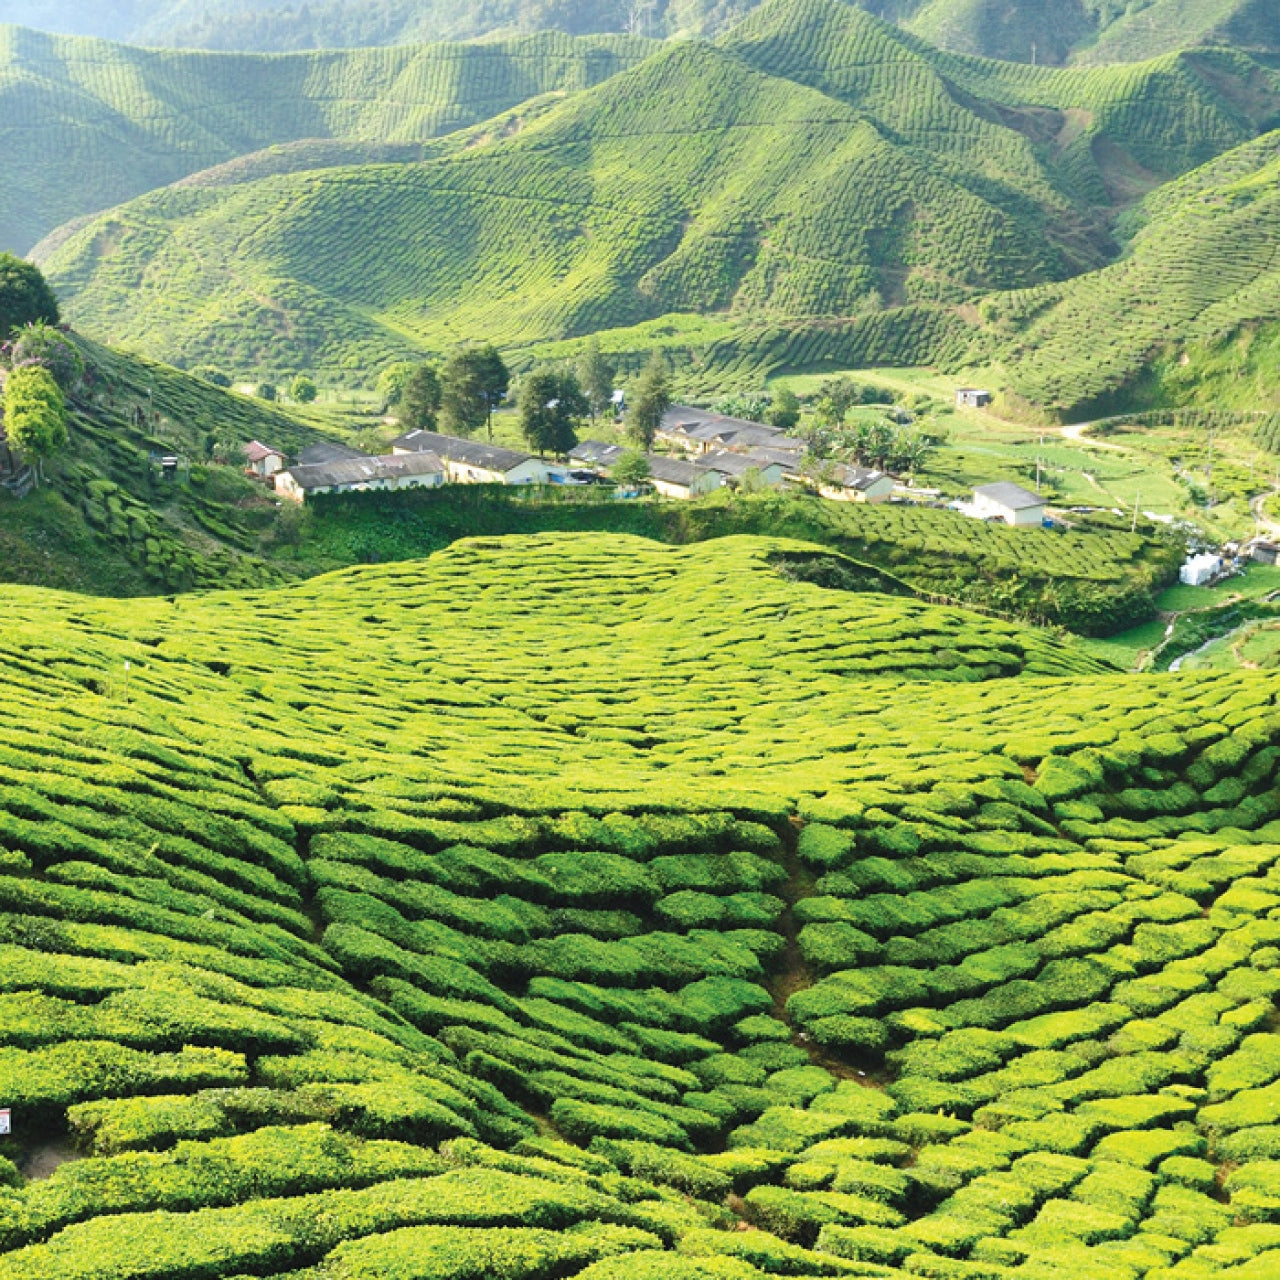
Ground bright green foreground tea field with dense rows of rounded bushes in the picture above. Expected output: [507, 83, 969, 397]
[0, 538, 1280, 1280]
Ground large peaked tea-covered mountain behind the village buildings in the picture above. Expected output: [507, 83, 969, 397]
[38, 0, 1280, 384]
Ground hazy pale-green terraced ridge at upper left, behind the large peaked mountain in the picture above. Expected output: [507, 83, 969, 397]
[0, 27, 648, 251]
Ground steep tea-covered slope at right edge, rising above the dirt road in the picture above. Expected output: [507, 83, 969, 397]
[984, 133, 1280, 413]
